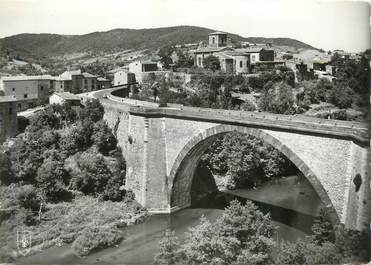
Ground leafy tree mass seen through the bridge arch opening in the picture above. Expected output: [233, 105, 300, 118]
[201, 132, 295, 189]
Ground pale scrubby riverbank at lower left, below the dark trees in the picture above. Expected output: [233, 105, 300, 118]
[0, 196, 148, 262]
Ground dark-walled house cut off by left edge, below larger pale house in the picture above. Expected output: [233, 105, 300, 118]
[0, 96, 17, 143]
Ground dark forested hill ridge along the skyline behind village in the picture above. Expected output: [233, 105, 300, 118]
[0, 26, 313, 57]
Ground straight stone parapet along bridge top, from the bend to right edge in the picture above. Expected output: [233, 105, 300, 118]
[129, 106, 370, 145]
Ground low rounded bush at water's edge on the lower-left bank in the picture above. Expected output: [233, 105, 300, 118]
[71, 226, 123, 256]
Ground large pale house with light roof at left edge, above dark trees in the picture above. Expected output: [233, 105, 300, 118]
[0, 75, 54, 111]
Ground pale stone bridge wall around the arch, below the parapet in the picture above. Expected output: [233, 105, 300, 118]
[100, 104, 370, 228]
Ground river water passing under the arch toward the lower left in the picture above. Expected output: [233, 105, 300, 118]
[17, 176, 321, 264]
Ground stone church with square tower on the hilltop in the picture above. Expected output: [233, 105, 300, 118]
[194, 31, 279, 74]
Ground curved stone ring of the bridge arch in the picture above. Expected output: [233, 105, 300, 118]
[168, 124, 340, 225]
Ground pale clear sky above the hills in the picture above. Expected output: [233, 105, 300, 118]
[0, 0, 371, 52]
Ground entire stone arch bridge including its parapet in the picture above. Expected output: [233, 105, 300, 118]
[86, 90, 370, 229]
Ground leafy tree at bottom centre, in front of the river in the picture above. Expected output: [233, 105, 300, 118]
[177, 200, 276, 264]
